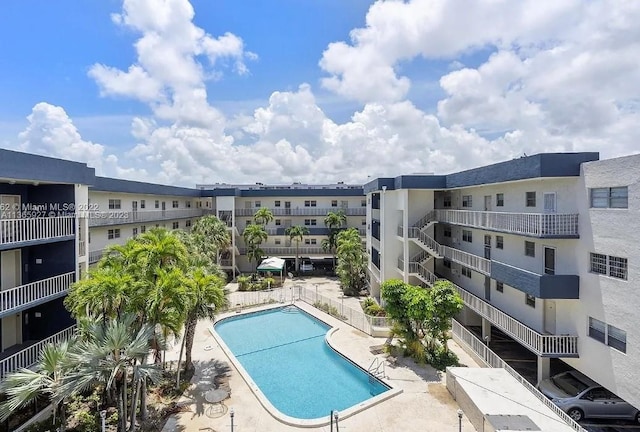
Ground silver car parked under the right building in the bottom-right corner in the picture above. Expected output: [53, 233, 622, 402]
[538, 371, 640, 423]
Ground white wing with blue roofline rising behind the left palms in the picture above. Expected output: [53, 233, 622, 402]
[87, 177, 212, 264]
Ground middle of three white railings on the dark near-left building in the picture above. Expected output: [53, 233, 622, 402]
[0, 272, 75, 312]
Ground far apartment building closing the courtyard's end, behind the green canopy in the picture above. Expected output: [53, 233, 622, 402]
[196, 183, 367, 272]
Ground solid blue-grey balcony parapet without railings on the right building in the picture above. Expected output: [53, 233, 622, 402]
[491, 261, 580, 299]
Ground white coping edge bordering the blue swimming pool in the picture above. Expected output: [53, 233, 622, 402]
[209, 302, 403, 428]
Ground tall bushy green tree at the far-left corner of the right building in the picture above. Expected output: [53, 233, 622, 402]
[336, 228, 367, 295]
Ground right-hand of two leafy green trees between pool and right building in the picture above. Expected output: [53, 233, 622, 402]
[426, 280, 464, 351]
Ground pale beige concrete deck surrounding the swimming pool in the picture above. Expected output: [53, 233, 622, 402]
[163, 278, 478, 432]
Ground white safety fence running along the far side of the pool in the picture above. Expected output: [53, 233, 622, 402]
[229, 285, 391, 335]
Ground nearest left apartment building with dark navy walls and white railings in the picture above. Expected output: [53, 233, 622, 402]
[0, 149, 94, 379]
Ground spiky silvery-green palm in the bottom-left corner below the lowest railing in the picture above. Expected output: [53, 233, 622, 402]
[0, 339, 75, 430]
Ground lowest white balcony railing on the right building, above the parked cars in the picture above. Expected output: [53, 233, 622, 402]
[454, 284, 578, 357]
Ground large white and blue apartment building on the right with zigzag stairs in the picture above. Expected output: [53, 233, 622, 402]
[364, 153, 640, 407]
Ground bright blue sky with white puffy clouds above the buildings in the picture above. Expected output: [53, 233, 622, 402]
[0, 0, 640, 186]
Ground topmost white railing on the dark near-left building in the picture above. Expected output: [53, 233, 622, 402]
[0, 216, 76, 245]
